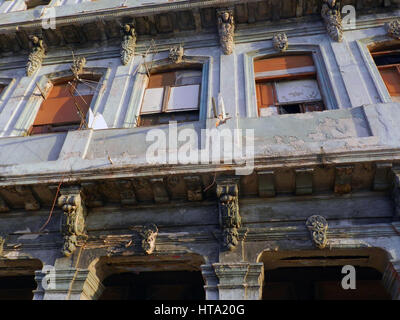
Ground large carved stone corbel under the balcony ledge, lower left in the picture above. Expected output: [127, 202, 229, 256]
[58, 187, 86, 257]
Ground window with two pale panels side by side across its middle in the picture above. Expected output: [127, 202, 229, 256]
[138, 69, 202, 126]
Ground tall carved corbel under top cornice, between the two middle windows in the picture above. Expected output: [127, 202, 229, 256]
[217, 9, 235, 55]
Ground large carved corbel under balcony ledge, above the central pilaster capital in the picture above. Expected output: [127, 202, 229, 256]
[217, 181, 242, 250]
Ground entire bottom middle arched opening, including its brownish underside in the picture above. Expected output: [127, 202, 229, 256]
[96, 254, 205, 300]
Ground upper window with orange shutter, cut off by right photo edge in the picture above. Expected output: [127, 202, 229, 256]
[371, 47, 400, 102]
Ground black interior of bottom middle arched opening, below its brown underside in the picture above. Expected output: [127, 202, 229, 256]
[100, 271, 205, 300]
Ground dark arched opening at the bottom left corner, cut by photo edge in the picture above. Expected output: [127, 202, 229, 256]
[0, 259, 42, 300]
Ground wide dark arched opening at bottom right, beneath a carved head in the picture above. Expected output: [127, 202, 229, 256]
[259, 248, 391, 300]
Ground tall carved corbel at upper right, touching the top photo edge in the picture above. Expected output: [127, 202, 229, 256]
[321, 0, 343, 42]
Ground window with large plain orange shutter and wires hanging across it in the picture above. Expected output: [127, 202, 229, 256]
[30, 79, 97, 135]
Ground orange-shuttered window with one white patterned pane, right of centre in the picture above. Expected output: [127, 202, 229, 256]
[254, 55, 325, 117]
